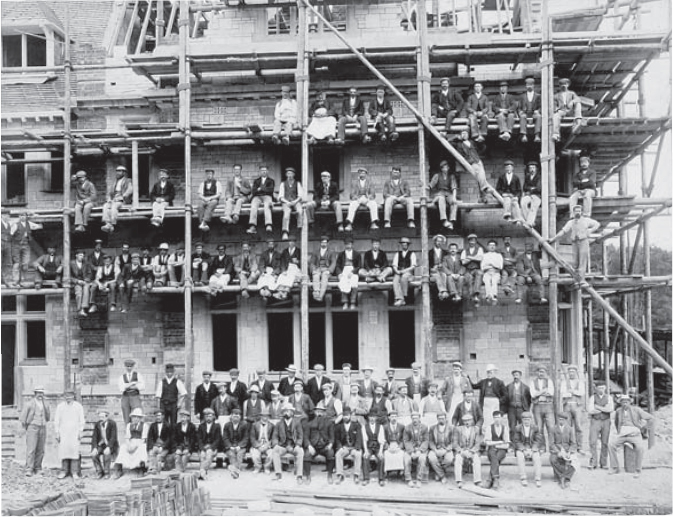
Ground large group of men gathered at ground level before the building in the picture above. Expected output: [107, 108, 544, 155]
[21, 360, 653, 489]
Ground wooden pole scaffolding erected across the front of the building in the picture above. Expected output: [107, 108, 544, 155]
[2, 0, 673, 410]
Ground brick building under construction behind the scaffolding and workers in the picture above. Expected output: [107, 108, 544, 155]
[1, 0, 671, 413]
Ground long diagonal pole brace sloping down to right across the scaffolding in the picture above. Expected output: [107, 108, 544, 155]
[297, 0, 673, 377]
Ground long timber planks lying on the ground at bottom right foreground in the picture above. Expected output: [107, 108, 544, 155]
[271, 487, 661, 515]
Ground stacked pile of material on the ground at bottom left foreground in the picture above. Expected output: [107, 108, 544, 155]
[81, 473, 210, 515]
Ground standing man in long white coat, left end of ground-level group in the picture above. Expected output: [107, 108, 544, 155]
[54, 390, 84, 479]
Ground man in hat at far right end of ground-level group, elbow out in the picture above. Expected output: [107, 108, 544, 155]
[608, 395, 654, 478]
